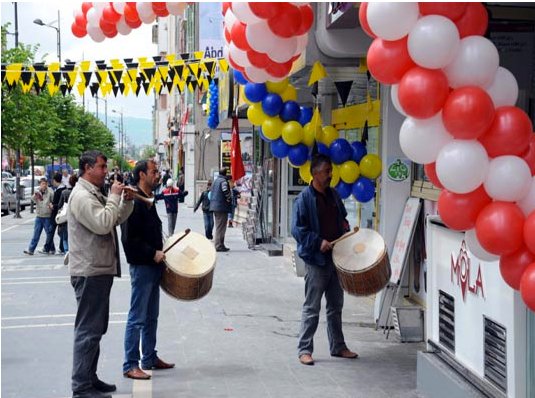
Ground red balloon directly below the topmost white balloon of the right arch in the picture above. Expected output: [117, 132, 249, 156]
[368, 36, 416, 84]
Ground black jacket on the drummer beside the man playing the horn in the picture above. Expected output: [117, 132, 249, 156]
[121, 187, 163, 266]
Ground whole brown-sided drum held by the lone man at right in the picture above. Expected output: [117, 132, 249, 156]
[333, 229, 392, 296]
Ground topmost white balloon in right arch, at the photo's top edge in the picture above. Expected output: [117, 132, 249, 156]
[366, 2, 419, 40]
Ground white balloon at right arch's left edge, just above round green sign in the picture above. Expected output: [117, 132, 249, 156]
[399, 112, 453, 164]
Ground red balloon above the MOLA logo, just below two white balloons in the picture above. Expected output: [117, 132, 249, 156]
[438, 185, 492, 231]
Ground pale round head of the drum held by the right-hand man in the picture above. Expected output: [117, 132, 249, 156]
[333, 229, 386, 272]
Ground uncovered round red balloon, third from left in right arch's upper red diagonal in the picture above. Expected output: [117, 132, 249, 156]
[442, 86, 494, 140]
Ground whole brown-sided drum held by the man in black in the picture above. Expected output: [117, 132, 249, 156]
[160, 232, 216, 301]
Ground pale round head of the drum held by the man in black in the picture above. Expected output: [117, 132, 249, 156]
[163, 231, 216, 277]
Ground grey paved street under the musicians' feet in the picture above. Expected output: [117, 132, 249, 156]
[1, 203, 424, 398]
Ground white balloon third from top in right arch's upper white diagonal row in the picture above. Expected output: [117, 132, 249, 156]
[443, 36, 500, 88]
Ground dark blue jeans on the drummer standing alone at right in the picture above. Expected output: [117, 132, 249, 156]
[297, 260, 347, 356]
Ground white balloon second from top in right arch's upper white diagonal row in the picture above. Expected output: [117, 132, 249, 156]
[407, 15, 461, 69]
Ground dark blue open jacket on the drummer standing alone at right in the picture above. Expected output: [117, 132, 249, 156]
[292, 184, 347, 265]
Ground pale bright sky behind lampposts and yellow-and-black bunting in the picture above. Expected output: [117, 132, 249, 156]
[1, 1, 157, 119]
